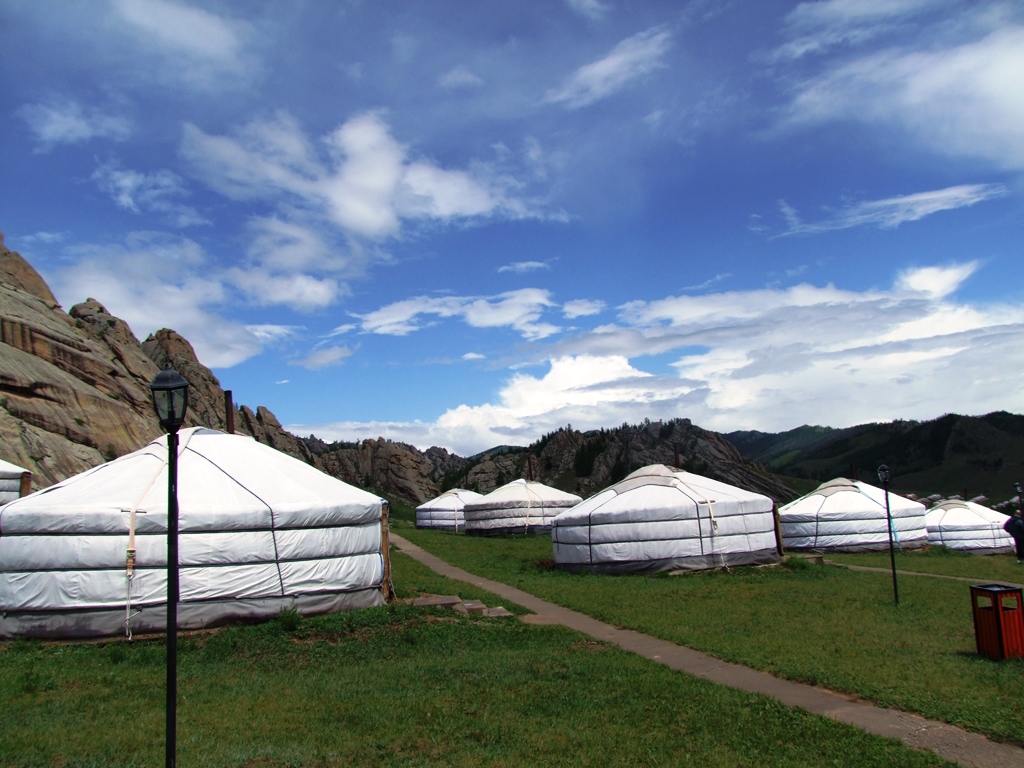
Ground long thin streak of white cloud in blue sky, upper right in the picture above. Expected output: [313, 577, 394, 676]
[779, 184, 1010, 234]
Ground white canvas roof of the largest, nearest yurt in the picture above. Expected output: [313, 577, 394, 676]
[0, 427, 380, 532]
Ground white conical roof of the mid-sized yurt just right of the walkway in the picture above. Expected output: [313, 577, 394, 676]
[555, 464, 772, 525]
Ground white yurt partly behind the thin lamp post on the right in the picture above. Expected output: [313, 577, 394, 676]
[778, 477, 928, 552]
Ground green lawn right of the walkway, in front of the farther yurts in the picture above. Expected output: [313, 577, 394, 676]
[394, 520, 1024, 744]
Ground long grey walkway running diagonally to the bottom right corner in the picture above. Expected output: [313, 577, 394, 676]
[390, 531, 1024, 768]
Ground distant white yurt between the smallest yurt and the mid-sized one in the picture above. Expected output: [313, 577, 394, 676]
[463, 480, 583, 536]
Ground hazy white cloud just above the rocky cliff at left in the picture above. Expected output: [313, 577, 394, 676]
[49, 232, 266, 368]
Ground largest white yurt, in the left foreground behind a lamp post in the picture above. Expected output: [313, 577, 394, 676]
[0, 427, 385, 637]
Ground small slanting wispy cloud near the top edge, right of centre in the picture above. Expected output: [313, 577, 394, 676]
[545, 27, 672, 110]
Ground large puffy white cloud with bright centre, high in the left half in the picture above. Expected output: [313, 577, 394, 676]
[181, 112, 539, 240]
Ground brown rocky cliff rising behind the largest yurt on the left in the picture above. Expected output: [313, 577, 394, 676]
[0, 234, 456, 504]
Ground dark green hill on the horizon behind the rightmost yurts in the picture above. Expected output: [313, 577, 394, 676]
[724, 411, 1024, 503]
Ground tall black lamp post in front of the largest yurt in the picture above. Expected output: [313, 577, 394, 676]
[150, 368, 188, 768]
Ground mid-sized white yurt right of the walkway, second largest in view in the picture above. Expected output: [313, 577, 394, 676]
[551, 464, 780, 573]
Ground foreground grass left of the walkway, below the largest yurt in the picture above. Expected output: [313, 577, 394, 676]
[0, 554, 949, 768]
